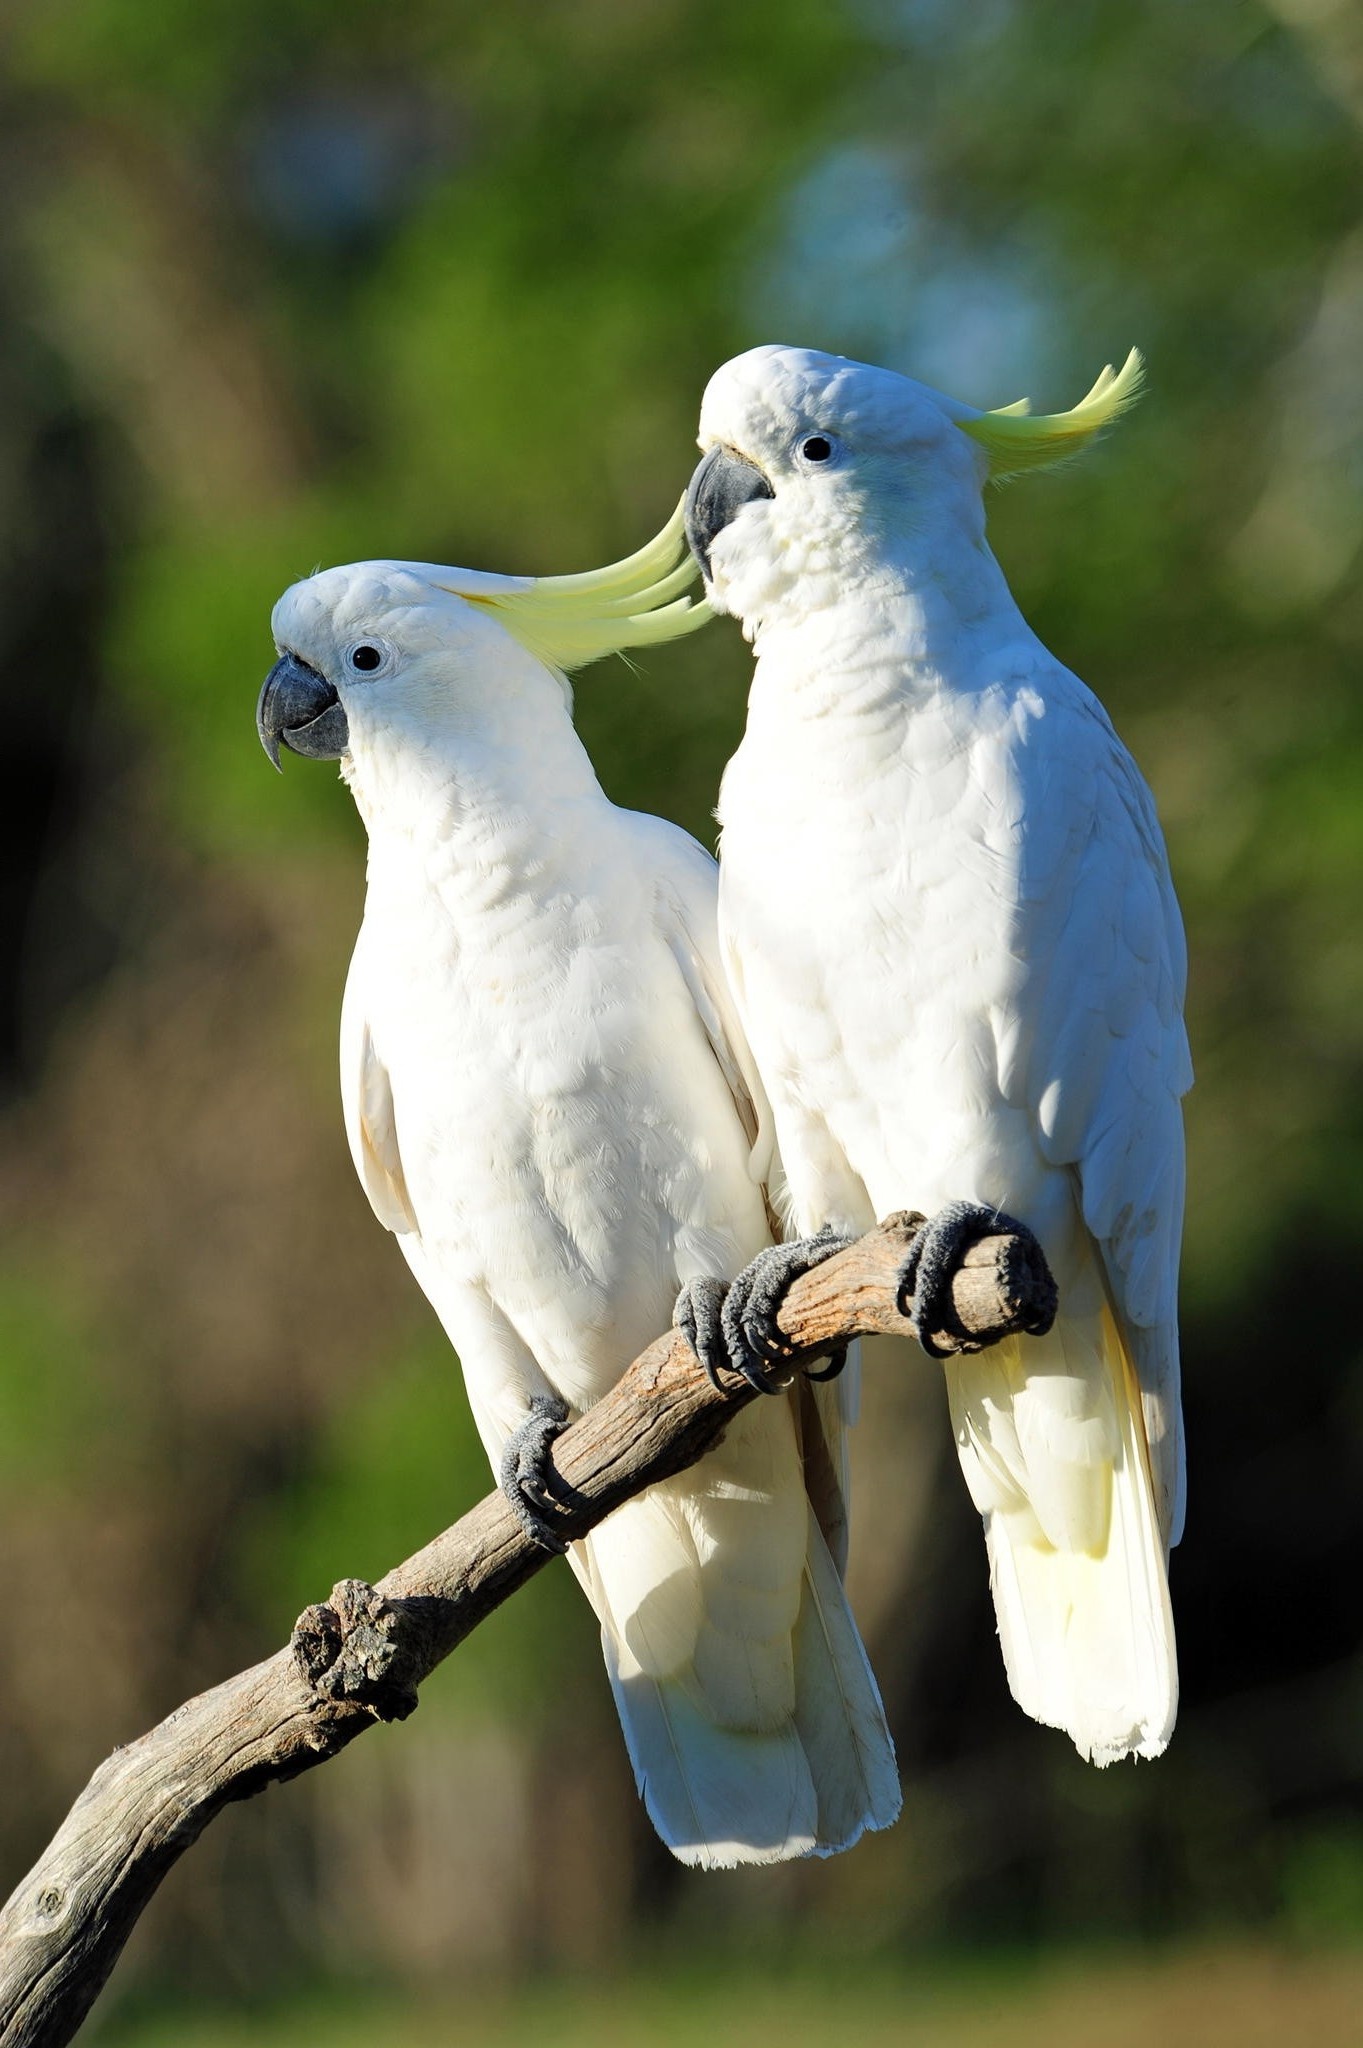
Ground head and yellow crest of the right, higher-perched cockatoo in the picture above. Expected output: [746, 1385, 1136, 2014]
[684, 344, 1142, 625]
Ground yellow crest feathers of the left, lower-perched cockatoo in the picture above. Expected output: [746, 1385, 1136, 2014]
[456, 504, 714, 670]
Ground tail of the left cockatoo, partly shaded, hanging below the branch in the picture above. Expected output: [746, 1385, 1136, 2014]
[571, 1401, 900, 1870]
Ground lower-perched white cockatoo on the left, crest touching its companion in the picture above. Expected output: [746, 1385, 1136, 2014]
[258, 514, 898, 1868]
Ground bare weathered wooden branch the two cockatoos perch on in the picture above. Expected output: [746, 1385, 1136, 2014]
[0, 1217, 1054, 2048]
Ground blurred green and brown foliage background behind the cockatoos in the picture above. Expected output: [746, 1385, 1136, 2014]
[0, 0, 1363, 2048]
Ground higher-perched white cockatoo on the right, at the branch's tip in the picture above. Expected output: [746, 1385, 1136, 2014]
[688, 346, 1191, 1763]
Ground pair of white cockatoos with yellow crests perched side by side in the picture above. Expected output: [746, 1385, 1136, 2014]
[258, 348, 1189, 1866]
